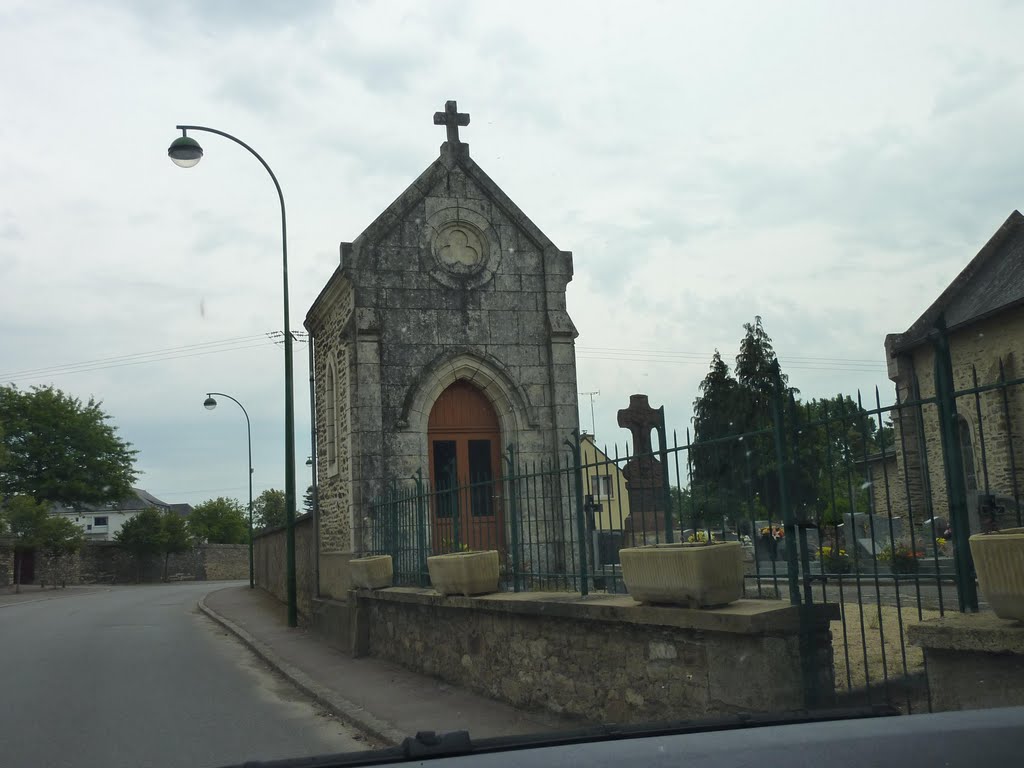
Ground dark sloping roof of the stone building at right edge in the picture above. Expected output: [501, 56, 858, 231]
[886, 210, 1024, 354]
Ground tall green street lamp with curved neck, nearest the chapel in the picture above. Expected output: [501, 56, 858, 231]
[167, 125, 299, 627]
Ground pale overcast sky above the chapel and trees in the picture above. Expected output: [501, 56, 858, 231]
[0, 0, 1024, 512]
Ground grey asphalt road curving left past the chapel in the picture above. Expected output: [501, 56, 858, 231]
[0, 584, 371, 768]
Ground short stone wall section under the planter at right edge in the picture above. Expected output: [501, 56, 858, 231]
[907, 611, 1024, 712]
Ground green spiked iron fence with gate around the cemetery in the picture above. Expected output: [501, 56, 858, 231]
[370, 342, 1024, 712]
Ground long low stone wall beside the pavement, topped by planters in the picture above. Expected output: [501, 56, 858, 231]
[352, 588, 838, 723]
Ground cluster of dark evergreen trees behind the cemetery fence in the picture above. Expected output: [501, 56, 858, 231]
[684, 317, 893, 526]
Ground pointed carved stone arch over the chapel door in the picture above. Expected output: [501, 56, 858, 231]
[397, 349, 537, 439]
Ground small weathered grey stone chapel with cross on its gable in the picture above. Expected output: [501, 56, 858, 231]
[305, 101, 579, 598]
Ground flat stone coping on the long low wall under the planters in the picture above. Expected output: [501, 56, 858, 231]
[354, 587, 840, 635]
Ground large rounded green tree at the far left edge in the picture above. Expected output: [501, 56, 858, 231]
[0, 386, 137, 506]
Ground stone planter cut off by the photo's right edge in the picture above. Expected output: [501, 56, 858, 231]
[970, 528, 1024, 622]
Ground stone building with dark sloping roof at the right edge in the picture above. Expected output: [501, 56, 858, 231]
[871, 211, 1024, 531]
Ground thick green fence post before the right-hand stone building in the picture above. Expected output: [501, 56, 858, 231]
[932, 315, 978, 613]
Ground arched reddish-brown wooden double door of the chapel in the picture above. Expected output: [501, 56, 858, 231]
[427, 380, 504, 553]
